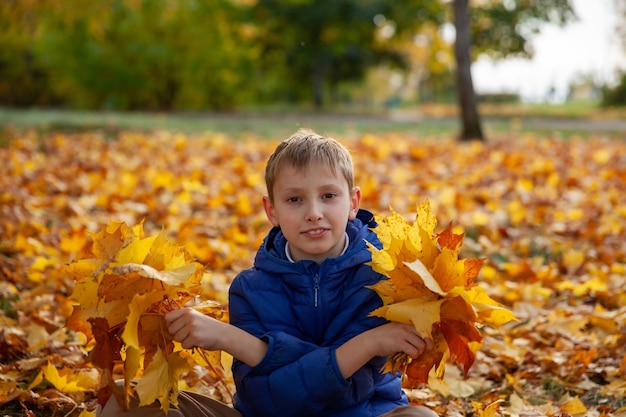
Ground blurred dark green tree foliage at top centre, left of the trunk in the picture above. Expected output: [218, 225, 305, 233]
[244, 0, 440, 107]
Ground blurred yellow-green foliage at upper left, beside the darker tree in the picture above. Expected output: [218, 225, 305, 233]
[7, 0, 253, 110]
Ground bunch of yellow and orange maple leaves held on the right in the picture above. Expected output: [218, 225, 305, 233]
[368, 200, 517, 388]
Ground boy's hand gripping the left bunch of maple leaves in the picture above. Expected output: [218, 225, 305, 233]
[165, 308, 228, 350]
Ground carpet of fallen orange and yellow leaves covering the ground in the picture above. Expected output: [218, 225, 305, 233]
[0, 130, 626, 416]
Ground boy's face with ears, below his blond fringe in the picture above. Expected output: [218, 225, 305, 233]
[263, 163, 361, 263]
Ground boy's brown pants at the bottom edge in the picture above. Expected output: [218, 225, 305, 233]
[97, 391, 437, 417]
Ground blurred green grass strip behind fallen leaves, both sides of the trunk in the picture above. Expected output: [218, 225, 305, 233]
[0, 103, 626, 139]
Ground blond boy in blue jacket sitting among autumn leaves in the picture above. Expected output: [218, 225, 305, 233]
[100, 130, 436, 417]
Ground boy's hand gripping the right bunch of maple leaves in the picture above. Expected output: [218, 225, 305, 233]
[364, 323, 434, 359]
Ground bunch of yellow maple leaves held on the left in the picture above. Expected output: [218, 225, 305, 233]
[66, 222, 223, 412]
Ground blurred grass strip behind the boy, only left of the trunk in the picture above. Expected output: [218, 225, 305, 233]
[0, 108, 458, 138]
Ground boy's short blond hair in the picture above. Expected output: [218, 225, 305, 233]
[265, 129, 354, 202]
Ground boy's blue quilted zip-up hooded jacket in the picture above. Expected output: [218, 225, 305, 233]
[229, 210, 407, 417]
